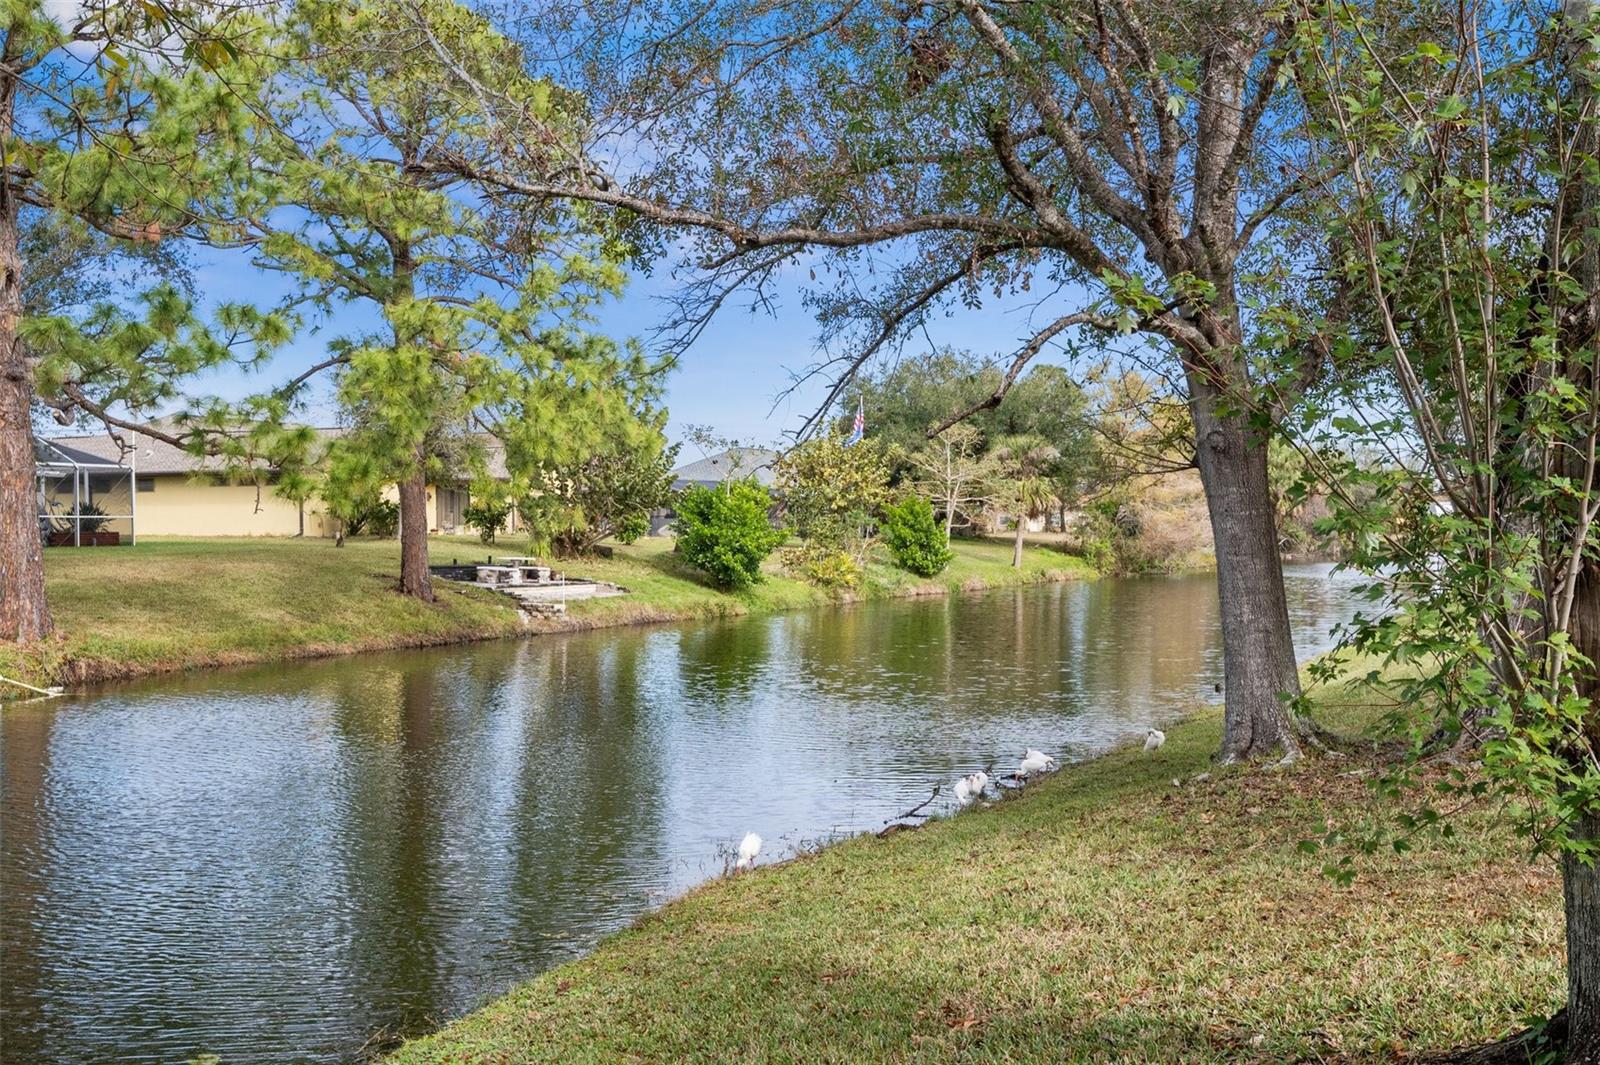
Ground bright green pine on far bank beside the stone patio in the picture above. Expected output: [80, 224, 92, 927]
[246, 0, 654, 600]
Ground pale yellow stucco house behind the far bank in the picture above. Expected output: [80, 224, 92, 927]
[40, 429, 486, 540]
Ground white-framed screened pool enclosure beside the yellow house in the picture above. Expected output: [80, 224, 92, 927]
[34, 438, 138, 547]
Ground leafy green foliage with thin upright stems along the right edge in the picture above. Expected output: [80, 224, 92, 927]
[1278, 5, 1600, 880]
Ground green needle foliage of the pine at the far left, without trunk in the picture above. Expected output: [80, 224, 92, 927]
[9, 0, 294, 470]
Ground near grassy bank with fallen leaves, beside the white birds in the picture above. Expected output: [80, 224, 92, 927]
[394, 681, 1563, 1065]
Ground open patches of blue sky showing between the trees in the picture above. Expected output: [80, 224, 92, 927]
[181, 241, 1094, 457]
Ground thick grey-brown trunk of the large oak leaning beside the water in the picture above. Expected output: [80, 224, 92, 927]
[1190, 393, 1299, 763]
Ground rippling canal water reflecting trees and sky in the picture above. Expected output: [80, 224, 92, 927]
[0, 566, 1355, 1065]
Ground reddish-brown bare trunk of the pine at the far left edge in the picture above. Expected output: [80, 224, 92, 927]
[0, 112, 51, 641]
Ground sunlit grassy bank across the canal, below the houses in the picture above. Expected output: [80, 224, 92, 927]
[0, 537, 1088, 684]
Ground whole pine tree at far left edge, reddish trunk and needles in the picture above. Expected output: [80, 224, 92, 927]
[0, 0, 285, 641]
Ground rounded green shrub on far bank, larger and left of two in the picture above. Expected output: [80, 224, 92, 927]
[677, 480, 784, 588]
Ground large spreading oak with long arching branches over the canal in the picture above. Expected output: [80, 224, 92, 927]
[432, 0, 1339, 760]
